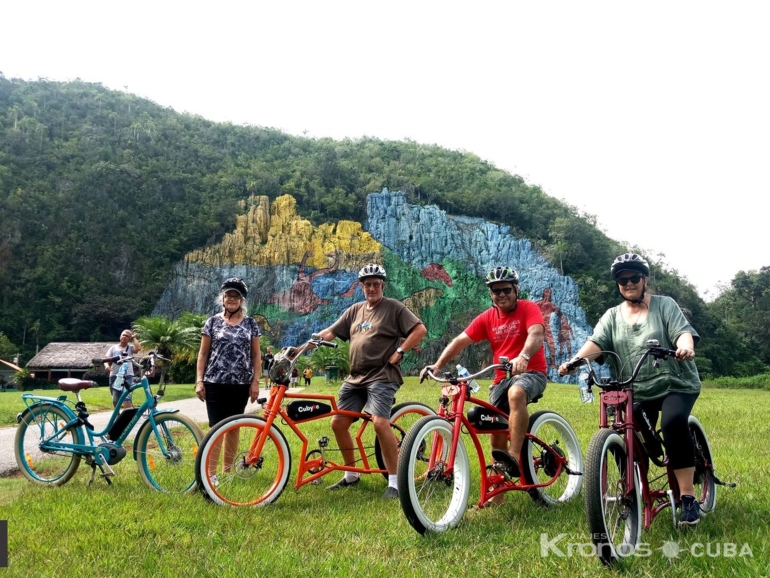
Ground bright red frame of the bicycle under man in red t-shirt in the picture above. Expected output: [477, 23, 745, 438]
[428, 376, 567, 506]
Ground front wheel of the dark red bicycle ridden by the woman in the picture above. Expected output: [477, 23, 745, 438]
[585, 429, 642, 565]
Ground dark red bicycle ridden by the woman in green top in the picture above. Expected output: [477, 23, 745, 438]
[567, 339, 735, 565]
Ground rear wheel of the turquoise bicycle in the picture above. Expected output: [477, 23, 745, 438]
[13, 403, 83, 486]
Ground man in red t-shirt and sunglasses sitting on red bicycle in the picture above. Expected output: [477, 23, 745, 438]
[420, 267, 546, 486]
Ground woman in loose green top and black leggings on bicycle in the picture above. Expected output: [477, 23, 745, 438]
[559, 253, 700, 526]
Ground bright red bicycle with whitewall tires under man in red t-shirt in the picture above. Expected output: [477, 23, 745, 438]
[398, 357, 583, 534]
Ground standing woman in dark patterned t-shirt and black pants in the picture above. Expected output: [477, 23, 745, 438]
[195, 277, 262, 485]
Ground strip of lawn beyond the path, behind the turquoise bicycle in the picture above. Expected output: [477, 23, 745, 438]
[0, 384, 195, 427]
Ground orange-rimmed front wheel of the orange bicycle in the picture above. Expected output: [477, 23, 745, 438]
[195, 414, 291, 506]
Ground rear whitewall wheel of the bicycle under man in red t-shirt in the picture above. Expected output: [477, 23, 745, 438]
[523, 411, 583, 506]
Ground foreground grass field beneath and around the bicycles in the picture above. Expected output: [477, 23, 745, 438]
[0, 378, 770, 578]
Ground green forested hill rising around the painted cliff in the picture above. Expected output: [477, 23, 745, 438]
[0, 74, 760, 374]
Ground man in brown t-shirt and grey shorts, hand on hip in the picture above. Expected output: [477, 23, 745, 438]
[320, 263, 428, 499]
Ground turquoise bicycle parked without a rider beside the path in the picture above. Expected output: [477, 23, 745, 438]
[14, 352, 203, 493]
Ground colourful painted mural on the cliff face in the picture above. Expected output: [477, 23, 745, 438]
[154, 190, 591, 381]
